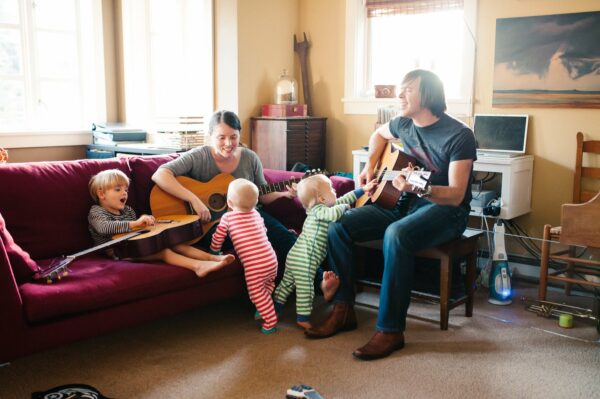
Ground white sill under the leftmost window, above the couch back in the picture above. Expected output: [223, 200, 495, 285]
[0, 130, 92, 148]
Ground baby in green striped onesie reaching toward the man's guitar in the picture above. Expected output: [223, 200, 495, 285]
[273, 175, 375, 329]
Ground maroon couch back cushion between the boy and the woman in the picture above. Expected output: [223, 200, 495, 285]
[128, 153, 179, 215]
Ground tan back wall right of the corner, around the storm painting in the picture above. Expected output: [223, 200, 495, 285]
[300, 0, 600, 237]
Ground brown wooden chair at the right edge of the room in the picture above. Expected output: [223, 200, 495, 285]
[538, 132, 600, 300]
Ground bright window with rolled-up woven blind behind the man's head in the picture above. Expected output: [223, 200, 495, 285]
[344, 0, 476, 116]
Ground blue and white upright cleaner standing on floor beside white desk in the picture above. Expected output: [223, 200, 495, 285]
[488, 219, 512, 305]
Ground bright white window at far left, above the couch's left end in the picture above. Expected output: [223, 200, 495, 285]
[0, 0, 106, 132]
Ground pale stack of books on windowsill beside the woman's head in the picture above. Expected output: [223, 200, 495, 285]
[152, 116, 205, 151]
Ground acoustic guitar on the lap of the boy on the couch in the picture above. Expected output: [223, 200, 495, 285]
[33, 215, 202, 284]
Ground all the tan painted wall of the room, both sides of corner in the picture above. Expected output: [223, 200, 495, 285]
[11, 0, 600, 237]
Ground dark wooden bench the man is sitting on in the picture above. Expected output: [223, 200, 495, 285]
[356, 229, 483, 330]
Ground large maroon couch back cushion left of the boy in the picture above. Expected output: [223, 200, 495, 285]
[0, 158, 135, 259]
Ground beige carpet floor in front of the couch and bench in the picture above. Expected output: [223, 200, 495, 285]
[0, 283, 600, 399]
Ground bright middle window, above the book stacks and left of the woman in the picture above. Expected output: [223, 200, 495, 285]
[122, 0, 213, 129]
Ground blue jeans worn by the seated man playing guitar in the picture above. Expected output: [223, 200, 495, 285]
[327, 198, 469, 332]
